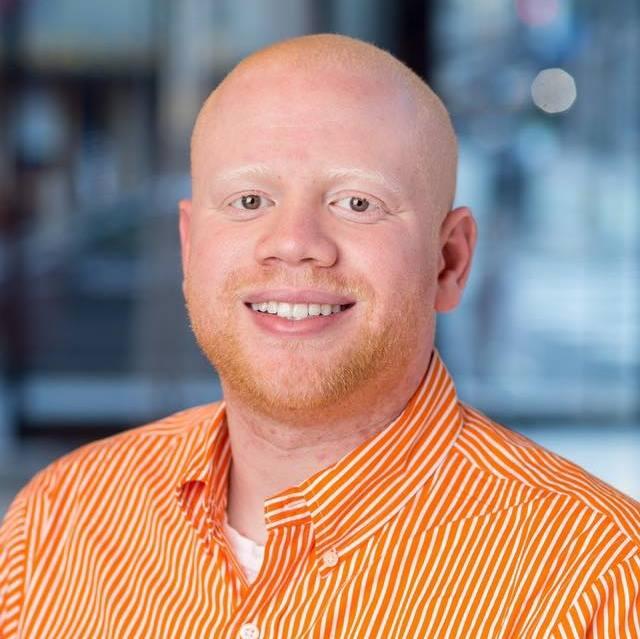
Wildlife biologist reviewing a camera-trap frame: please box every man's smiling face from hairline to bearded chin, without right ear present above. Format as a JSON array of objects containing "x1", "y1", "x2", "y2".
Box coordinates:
[{"x1": 181, "y1": 63, "x2": 438, "y2": 419}]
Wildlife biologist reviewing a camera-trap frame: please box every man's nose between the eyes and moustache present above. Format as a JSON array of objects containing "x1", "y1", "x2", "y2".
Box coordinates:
[{"x1": 256, "y1": 197, "x2": 338, "y2": 267}]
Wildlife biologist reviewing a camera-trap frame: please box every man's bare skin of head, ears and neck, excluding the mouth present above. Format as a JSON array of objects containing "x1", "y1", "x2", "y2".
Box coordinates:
[{"x1": 180, "y1": 34, "x2": 477, "y2": 543}]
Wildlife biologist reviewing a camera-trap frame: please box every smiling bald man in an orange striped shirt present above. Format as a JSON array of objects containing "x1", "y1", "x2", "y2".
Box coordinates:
[{"x1": 0, "y1": 35, "x2": 640, "y2": 639}]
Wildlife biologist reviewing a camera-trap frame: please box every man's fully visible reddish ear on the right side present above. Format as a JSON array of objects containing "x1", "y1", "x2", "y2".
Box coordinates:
[{"x1": 435, "y1": 206, "x2": 478, "y2": 313}]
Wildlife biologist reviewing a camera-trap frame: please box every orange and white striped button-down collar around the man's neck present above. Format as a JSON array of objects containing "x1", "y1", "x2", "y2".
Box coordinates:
[{"x1": 177, "y1": 348, "x2": 462, "y2": 576}]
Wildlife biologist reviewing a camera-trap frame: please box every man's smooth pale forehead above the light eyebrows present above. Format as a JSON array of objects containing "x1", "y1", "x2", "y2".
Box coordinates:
[{"x1": 198, "y1": 68, "x2": 415, "y2": 153}]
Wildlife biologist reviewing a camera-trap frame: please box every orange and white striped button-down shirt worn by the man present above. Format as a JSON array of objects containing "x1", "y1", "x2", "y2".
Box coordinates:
[{"x1": 0, "y1": 350, "x2": 640, "y2": 639}]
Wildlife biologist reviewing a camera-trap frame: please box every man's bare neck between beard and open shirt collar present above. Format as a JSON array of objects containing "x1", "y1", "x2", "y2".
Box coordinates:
[{"x1": 223, "y1": 356, "x2": 425, "y2": 544}]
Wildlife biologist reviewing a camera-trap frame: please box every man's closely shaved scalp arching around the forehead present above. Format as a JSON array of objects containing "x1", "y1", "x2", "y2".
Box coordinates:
[{"x1": 191, "y1": 34, "x2": 457, "y2": 221}]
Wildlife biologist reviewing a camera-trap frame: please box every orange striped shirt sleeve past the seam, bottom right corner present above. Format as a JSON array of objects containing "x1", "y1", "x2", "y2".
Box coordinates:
[{"x1": 553, "y1": 554, "x2": 640, "y2": 639}]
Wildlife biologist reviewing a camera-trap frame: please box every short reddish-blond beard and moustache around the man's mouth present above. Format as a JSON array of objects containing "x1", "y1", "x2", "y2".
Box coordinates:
[{"x1": 184, "y1": 268, "x2": 432, "y2": 425}]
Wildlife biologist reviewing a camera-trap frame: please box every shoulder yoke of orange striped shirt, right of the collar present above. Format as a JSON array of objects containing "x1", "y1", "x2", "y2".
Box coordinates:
[{"x1": 456, "y1": 404, "x2": 640, "y2": 548}]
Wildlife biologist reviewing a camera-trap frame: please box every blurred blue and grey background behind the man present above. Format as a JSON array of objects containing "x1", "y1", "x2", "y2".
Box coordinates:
[{"x1": 0, "y1": 0, "x2": 640, "y2": 515}]
